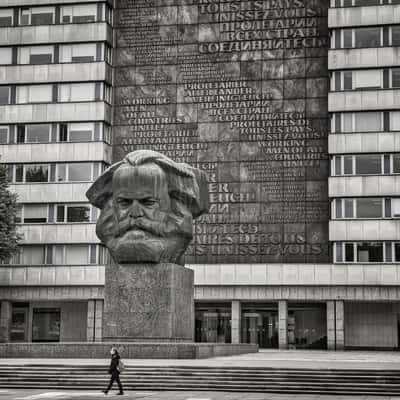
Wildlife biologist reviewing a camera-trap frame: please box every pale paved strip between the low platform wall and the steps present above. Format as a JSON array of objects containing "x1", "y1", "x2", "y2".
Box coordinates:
[{"x1": 0, "y1": 350, "x2": 400, "y2": 370}]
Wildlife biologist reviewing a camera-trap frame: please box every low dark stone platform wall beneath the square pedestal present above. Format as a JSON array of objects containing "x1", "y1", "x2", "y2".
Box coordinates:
[{"x1": 0, "y1": 342, "x2": 258, "y2": 359}]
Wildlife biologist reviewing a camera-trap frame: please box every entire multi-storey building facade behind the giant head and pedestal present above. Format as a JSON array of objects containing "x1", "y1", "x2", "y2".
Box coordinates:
[{"x1": 0, "y1": 0, "x2": 400, "y2": 349}]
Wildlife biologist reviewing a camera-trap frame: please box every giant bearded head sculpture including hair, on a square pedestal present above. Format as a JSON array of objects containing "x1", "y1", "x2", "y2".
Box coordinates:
[{"x1": 86, "y1": 150, "x2": 208, "y2": 264}]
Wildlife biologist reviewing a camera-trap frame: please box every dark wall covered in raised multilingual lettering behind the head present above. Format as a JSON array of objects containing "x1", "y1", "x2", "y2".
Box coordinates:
[{"x1": 114, "y1": 0, "x2": 329, "y2": 263}]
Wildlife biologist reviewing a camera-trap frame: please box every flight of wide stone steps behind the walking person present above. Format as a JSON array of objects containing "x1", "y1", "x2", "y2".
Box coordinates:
[{"x1": 0, "y1": 364, "x2": 400, "y2": 396}]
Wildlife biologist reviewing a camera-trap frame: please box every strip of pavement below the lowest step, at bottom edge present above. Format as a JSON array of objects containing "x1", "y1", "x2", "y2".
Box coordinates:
[{"x1": 0, "y1": 389, "x2": 400, "y2": 400}]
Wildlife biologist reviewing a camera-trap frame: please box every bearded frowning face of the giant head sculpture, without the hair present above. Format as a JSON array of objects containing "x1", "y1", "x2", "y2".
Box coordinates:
[{"x1": 97, "y1": 163, "x2": 192, "y2": 263}]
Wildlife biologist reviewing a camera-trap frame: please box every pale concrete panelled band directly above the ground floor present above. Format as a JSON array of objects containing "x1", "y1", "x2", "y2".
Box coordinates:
[{"x1": 0, "y1": 264, "x2": 400, "y2": 290}]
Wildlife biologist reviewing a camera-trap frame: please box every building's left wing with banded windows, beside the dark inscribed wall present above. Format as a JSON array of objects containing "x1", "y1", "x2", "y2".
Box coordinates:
[{"x1": 0, "y1": 0, "x2": 112, "y2": 341}]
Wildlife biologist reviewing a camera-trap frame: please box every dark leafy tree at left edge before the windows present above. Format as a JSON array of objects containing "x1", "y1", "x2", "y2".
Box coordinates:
[{"x1": 0, "y1": 165, "x2": 21, "y2": 262}]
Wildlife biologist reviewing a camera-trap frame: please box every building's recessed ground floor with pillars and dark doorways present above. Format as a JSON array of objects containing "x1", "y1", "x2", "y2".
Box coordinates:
[{"x1": 0, "y1": 299, "x2": 400, "y2": 350}]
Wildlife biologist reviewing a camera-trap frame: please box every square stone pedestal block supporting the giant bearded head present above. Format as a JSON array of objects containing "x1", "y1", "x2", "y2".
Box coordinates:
[{"x1": 103, "y1": 263, "x2": 194, "y2": 342}]
